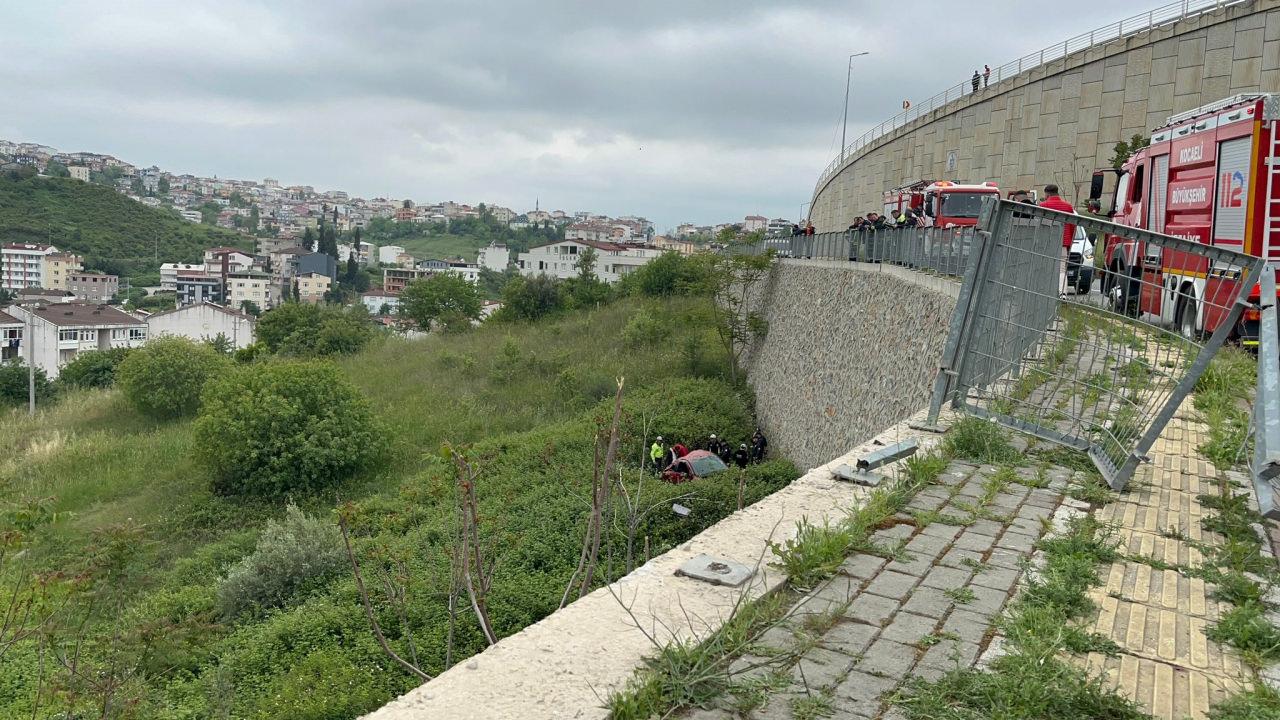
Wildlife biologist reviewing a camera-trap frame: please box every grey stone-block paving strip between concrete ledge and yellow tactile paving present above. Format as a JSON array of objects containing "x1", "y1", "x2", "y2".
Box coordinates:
[{"x1": 684, "y1": 462, "x2": 1075, "y2": 720}]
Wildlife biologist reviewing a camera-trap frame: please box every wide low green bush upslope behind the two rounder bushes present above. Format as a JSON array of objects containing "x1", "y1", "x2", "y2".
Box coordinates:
[{"x1": 256, "y1": 302, "x2": 374, "y2": 357}]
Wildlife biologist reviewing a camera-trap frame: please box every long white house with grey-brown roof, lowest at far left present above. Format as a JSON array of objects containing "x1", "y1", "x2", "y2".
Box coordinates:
[{"x1": 6, "y1": 302, "x2": 147, "y2": 378}]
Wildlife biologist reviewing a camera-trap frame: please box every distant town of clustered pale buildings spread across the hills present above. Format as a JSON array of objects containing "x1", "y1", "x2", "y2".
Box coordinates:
[{"x1": 0, "y1": 140, "x2": 790, "y2": 378}]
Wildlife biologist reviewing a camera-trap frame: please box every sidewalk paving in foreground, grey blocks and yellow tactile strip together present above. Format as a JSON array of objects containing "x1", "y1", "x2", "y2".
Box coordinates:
[{"x1": 684, "y1": 407, "x2": 1269, "y2": 720}]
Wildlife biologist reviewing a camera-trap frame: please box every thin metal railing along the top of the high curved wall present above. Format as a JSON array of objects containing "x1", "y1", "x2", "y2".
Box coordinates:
[{"x1": 814, "y1": 0, "x2": 1252, "y2": 195}]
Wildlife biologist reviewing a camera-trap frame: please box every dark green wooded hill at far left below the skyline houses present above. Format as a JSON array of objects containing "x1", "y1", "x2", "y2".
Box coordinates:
[{"x1": 0, "y1": 176, "x2": 252, "y2": 277}]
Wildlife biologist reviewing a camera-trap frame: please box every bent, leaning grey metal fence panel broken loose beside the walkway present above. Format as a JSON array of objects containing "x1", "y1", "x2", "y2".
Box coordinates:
[{"x1": 931, "y1": 200, "x2": 1264, "y2": 489}]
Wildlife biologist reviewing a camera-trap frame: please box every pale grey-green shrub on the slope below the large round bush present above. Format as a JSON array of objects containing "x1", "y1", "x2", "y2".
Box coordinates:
[{"x1": 218, "y1": 503, "x2": 346, "y2": 618}]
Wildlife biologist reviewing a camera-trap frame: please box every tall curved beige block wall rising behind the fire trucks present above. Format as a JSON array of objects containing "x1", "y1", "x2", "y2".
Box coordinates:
[{"x1": 810, "y1": 0, "x2": 1280, "y2": 232}]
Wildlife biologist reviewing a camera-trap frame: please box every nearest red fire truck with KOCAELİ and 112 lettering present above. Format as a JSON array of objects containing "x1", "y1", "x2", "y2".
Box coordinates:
[{"x1": 1094, "y1": 94, "x2": 1280, "y2": 345}]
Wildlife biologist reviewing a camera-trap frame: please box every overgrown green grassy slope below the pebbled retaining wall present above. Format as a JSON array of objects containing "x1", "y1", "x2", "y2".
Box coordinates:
[{"x1": 0, "y1": 299, "x2": 796, "y2": 720}]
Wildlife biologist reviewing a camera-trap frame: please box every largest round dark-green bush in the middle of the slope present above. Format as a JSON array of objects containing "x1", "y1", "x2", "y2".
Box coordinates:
[{"x1": 195, "y1": 361, "x2": 387, "y2": 495}]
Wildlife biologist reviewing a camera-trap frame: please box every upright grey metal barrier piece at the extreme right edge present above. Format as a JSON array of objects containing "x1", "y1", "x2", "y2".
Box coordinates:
[{"x1": 1251, "y1": 265, "x2": 1280, "y2": 520}]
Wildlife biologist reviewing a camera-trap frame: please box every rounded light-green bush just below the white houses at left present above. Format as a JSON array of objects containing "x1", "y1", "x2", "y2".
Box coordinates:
[{"x1": 115, "y1": 337, "x2": 230, "y2": 418}]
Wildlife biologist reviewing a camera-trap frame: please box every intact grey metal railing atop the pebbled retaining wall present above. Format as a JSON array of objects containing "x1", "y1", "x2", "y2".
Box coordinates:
[{"x1": 740, "y1": 228, "x2": 977, "y2": 277}]
